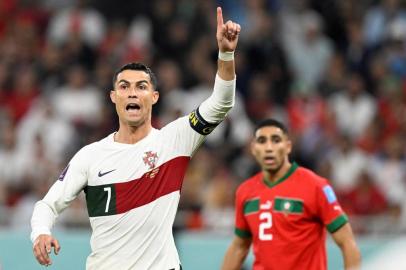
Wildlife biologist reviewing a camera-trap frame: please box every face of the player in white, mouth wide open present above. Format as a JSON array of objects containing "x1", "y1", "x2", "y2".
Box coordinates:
[{"x1": 110, "y1": 70, "x2": 159, "y2": 127}]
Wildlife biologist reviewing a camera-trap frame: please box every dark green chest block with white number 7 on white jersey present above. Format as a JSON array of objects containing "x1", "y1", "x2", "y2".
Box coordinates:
[{"x1": 85, "y1": 184, "x2": 117, "y2": 217}]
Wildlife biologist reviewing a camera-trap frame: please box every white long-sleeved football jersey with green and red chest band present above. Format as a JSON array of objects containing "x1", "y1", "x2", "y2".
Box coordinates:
[{"x1": 31, "y1": 74, "x2": 235, "y2": 270}]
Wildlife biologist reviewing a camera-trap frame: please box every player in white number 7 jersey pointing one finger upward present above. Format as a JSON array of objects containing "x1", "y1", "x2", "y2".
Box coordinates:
[{"x1": 31, "y1": 8, "x2": 241, "y2": 270}]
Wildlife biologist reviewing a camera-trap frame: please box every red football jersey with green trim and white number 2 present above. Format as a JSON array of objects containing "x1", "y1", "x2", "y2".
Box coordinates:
[{"x1": 235, "y1": 163, "x2": 348, "y2": 270}]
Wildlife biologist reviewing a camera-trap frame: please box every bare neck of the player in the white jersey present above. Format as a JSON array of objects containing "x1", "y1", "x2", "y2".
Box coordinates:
[{"x1": 114, "y1": 123, "x2": 152, "y2": 144}]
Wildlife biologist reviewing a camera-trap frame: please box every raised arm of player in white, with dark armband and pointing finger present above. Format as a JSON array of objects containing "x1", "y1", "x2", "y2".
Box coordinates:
[{"x1": 165, "y1": 7, "x2": 241, "y2": 155}]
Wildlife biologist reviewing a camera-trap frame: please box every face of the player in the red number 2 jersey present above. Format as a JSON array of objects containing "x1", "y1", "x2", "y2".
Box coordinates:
[{"x1": 251, "y1": 126, "x2": 292, "y2": 173}]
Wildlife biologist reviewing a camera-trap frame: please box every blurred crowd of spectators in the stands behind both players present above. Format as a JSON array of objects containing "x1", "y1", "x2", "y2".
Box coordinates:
[{"x1": 0, "y1": 0, "x2": 406, "y2": 234}]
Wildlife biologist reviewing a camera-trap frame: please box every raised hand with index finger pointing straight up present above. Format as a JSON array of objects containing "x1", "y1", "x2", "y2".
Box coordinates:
[{"x1": 216, "y1": 7, "x2": 241, "y2": 52}]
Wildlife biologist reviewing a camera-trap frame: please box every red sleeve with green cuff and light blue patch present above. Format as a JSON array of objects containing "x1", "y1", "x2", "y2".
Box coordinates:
[{"x1": 316, "y1": 180, "x2": 348, "y2": 233}]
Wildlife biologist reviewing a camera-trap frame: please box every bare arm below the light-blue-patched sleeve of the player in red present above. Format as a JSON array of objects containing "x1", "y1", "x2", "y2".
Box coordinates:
[{"x1": 332, "y1": 223, "x2": 361, "y2": 270}]
